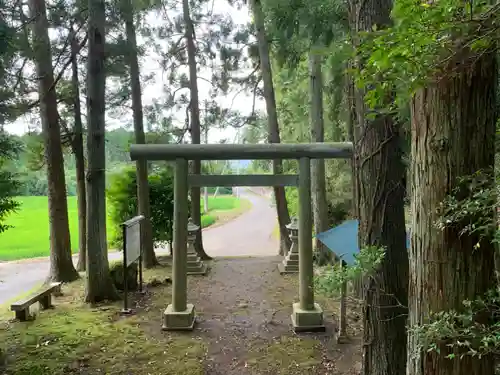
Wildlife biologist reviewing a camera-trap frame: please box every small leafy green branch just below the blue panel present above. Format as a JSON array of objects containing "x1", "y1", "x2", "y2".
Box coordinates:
[{"x1": 314, "y1": 246, "x2": 385, "y2": 296}]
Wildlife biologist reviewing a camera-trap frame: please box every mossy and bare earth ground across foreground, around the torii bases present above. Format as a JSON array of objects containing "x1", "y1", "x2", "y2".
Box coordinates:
[{"x1": 0, "y1": 257, "x2": 358, "y2": 375}]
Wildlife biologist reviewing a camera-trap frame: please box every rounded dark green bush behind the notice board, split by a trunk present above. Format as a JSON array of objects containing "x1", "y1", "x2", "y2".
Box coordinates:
[{"x1": 107, "y1": 167, "x2": 179, "y2": 248}]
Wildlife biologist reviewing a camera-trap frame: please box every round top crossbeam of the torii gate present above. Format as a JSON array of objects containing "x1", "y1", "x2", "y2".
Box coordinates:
[{"x1": 130, "y1": 142, "x2": 353, "y2": 160}]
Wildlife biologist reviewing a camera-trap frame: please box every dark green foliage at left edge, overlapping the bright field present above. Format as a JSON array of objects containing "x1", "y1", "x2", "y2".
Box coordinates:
[{"x1": 0, "y1": 130, "x2": 21, "y2": 233}]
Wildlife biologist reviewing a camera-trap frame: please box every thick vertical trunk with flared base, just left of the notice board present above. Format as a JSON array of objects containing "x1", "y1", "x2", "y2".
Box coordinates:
[{"x1": 85, "y1": 0, "x2": 119, "y2": 303}]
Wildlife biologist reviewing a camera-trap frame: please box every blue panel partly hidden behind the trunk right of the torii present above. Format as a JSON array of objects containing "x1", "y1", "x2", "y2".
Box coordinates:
[{"x1": 316, "y1": 220, "x2": 410, "y2": 265}]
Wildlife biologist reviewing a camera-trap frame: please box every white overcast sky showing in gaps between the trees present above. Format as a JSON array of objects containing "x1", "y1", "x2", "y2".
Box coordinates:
[{"x1": 5, "y1": 0, "x2": 265, "y2": 143}]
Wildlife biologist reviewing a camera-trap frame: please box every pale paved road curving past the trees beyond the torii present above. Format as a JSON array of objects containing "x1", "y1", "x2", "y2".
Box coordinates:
[{"x1": 0, "y1": 191, "x2": 278, "y2": 304}]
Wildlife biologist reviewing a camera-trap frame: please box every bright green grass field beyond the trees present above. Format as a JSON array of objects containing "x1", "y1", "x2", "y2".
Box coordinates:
[{"x1": 0, "y1": 195, "x2": 241, "y2": 261}]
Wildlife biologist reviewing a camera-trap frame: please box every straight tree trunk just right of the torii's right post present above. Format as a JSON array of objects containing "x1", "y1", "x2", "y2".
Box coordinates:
[{"x1": 309, "y1": 51, "x2": 332, "y2": 265}]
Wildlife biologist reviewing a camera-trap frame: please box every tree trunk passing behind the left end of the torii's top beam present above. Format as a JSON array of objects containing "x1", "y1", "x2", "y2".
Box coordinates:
[{"x1": 123, "y1": 0, "x2": 158, "y2": 268}]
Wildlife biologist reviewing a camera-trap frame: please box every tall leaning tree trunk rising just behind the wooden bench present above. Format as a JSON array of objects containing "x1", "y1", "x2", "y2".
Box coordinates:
[{"x1": 29, "y1": 0, "x2": 79, "y2": 282}]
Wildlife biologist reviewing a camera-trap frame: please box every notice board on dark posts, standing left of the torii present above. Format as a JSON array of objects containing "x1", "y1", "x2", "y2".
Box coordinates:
[{"x1": 121, "y1": 215, "x2": 144, "y2": 315}]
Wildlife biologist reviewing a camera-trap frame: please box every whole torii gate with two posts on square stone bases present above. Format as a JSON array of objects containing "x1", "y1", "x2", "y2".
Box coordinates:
[{"x1": 130, "y1": 143, "x2": 352, "y2": 332}]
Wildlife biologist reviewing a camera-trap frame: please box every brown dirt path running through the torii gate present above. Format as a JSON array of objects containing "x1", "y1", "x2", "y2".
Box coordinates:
[{"x1": 189, "y1": 257, "x2": 359, "y2": 375}]
